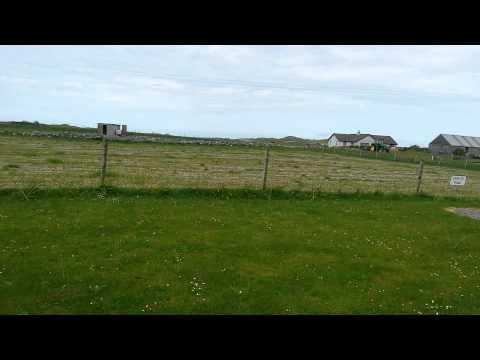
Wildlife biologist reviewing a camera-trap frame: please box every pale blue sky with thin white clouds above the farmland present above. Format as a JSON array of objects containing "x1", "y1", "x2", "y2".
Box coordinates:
[{"x1": 0, "y1": 45, "x2": 480, "y2": 146}]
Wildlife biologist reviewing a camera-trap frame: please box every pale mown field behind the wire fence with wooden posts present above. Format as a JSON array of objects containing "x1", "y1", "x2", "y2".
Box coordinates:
[{"x1": 0, "y1": 136, "x2": 480, "y2": 197}]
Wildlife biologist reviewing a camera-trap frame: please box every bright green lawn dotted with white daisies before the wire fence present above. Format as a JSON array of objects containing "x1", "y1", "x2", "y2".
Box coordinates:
[{"x1": 0, "y1": 190, "x2": 480, "y2": 314}]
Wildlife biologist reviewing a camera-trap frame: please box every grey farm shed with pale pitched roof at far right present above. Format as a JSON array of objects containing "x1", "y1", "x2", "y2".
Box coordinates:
[{"x1": 429, "y1": 134, "x2": 480, "y2": 156}]
